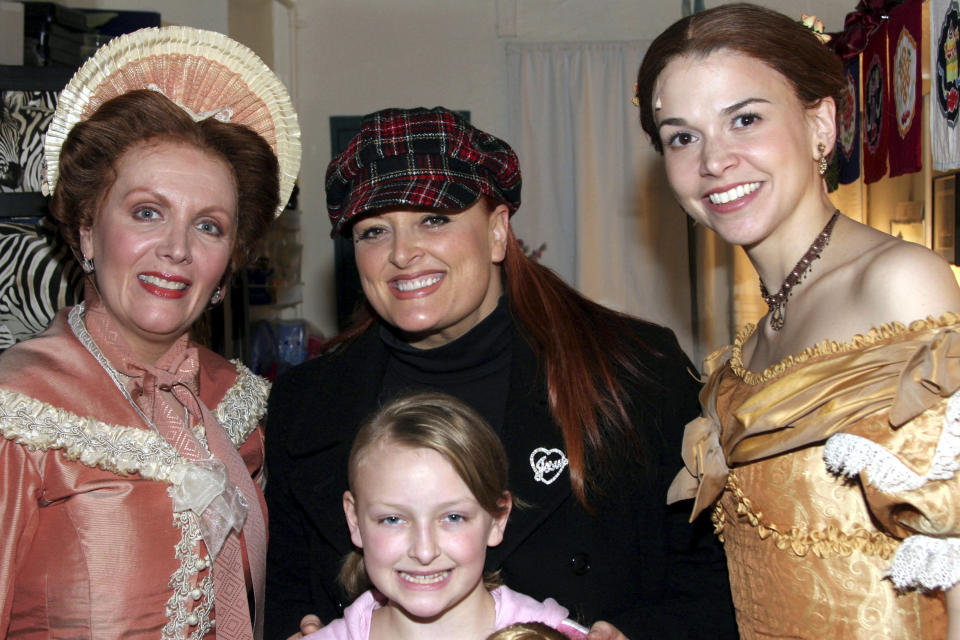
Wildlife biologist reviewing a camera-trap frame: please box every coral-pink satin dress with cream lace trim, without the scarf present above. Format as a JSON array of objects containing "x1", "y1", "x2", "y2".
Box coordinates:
[{"x1": 0, "y1": 296, "x2": 268, "y2": 639}]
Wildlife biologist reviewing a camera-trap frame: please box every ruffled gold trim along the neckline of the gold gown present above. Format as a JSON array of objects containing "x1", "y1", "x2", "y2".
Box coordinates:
[{"x1": 730, "y1": 312, "x2": 960, "y2": 385}]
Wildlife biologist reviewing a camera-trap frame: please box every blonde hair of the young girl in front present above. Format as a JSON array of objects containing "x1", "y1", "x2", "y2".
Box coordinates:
[{"x1": 338, "y1": 392, "x2": 510, "y2": 599}]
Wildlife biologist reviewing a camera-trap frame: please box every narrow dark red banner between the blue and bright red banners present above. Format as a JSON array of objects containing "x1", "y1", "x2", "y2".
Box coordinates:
[{"x1": 863, "y1": 23, "x2": 889, "y2": 184}]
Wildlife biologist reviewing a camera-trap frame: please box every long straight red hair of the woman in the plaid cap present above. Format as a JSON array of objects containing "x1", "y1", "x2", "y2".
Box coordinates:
[{"x1": 324, "y1": 212, "x2": 659, "y2": 508}]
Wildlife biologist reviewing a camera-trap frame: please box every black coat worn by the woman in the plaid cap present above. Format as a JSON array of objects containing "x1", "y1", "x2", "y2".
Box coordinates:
[{"x1": 265, "y1": 322, "x2": 737, "y2": 640}]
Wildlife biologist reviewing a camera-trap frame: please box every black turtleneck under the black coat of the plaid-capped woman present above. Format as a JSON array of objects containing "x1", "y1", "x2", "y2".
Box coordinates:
[{"x1": 379, "y1": 296, "x2": 513, "y2": 434}]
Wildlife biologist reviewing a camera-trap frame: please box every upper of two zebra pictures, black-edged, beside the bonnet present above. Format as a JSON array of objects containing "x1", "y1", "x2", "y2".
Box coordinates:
[{"x1": 0, "y1": 66, "x2": 74, "y2": 218}]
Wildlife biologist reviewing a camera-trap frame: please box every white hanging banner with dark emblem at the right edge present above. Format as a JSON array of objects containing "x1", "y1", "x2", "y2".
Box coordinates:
[{"x1": 930, "y1": 0, "x2": 960, "y2": 171}]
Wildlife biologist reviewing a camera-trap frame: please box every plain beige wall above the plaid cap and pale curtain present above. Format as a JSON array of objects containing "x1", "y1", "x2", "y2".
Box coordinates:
[{"x1": 274, "y1": 0, "x2": 856, "y2": 332}]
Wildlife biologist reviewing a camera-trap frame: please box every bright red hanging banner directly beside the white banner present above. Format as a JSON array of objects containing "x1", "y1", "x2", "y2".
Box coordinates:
[{"x1": 887, "y1": 0, "x2": 923, "y2": 178}]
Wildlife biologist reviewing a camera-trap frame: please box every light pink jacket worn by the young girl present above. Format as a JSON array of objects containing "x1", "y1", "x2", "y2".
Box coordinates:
[{"x1": 306, "y1": 587, "x2": 587, "y2": 640}]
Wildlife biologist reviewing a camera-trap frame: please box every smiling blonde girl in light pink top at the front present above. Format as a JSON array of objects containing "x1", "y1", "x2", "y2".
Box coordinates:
[{"x1": 308, "y1": 393, "x2": 586, "y2": 640}]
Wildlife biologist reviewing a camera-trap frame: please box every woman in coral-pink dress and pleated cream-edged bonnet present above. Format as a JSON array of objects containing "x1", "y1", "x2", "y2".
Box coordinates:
[{"x1": 0, "y1": 28, "x2": 299, "y2": 639}]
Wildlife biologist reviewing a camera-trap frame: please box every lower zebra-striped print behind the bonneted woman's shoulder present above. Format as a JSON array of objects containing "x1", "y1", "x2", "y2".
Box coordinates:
[{"x1": 0, "y1": 222, "x2": 83, "y2": 349}]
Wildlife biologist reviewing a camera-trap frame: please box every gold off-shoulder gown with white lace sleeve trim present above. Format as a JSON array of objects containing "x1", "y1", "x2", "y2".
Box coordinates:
[{"x1": 671, "y1": 314, "x2": 960, "y2": 640}]
